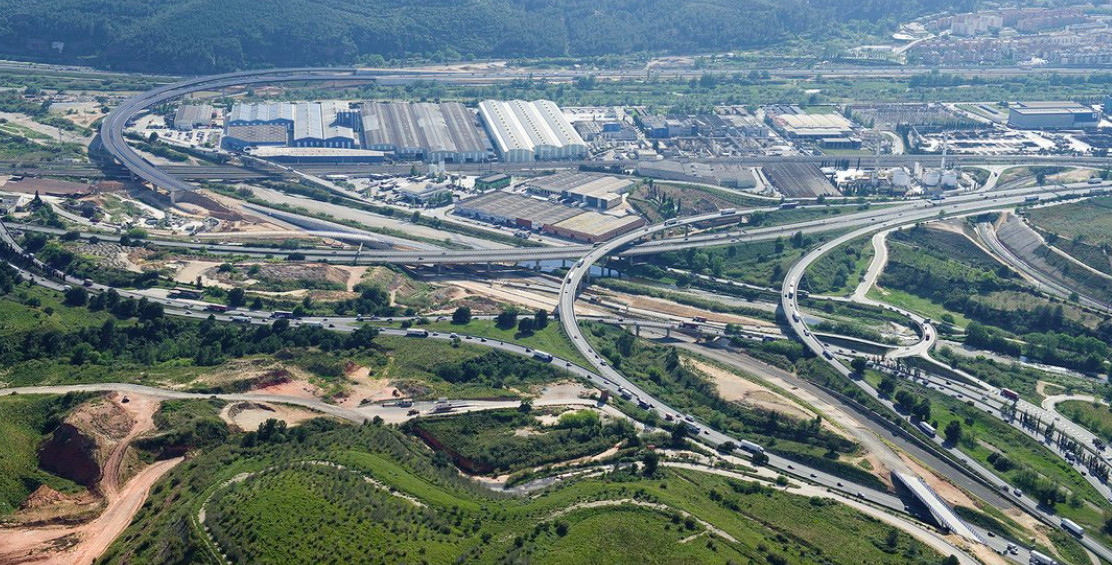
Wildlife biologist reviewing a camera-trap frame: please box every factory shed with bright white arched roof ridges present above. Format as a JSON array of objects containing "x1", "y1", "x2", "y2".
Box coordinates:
[{"x1": 479, "y1": 100, "x2": 587, "y2": 162}]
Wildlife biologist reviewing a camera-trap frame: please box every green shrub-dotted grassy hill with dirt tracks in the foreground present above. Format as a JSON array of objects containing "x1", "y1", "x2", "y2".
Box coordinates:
[{"x1": 101, "y1": 418, "x2": 942, "y2": 565}]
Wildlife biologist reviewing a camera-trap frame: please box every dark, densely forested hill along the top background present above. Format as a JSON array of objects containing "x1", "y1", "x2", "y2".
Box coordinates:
[{"x1": 0, "y1": 0, "x2": 974, "y2": 73}]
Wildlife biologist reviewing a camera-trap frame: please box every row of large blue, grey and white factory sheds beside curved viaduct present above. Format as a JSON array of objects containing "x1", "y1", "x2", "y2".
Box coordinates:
[{"x1": 223, "y1": 100, "x2": 587, "y2": 162}]
